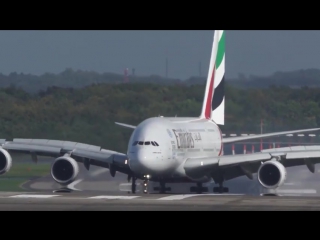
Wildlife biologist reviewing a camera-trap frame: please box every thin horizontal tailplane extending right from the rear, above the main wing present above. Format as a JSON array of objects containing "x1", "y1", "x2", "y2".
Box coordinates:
[{"x1": 222, "y1": 128, "x2": 320, "y2": 143}]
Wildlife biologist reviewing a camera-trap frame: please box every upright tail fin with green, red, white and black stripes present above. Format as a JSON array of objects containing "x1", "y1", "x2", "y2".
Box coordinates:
[{"x1": 200, "y1": 30, "x2": 225, "y2": 125}]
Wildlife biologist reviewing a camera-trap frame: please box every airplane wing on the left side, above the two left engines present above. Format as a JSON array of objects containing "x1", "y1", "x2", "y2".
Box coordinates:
[{"x1": 0, "y1": 138, "x2": 130, "y2": 174}]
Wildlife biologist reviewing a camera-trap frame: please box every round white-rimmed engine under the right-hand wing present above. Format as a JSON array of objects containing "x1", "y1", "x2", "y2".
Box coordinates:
[{"x1": 258, "y1": 161, "x2": 287, "y2": 189}]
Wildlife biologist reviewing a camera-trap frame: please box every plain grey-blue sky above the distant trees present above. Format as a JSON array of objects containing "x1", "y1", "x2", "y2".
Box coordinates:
[{"x1": 0, "y1": 30, "x2": 320, "y2": 80}]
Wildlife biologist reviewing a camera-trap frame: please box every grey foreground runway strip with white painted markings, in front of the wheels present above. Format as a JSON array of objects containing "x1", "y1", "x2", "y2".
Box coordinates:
[{"x1": 0, "y1": 193, "x2": 320, "y2": 211}]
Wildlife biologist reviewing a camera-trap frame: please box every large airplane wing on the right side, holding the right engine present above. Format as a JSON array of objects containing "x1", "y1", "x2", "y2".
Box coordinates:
[{"x1": 184, "y1": 146, "x2": 320, "y2": 180}]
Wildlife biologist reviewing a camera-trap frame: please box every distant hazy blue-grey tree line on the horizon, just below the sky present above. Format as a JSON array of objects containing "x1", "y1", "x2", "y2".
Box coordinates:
[{"x1": 0, "y1": 68, "x2": 320, "y2": 93}]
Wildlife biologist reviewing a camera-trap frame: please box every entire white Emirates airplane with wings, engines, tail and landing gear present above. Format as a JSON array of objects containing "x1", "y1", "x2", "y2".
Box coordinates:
[{"x1": 0, "y1": 30, "x2": 320, "y2": 193}]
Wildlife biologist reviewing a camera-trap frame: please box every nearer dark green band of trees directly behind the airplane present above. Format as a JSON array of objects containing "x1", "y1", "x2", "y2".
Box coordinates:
[{"x1": 0, "y1": 82, "x2": 320, "y2": 152}]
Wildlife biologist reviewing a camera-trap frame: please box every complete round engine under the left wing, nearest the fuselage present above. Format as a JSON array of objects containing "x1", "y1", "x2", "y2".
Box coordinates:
[{"x1": 51, "y1": 156, "x2": 79, "y2": 186}]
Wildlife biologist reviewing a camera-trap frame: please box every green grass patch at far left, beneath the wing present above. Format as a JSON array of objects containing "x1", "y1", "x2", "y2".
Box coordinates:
[{"x1": 0, "y1": 161, "x2": 51, "y2": 191}]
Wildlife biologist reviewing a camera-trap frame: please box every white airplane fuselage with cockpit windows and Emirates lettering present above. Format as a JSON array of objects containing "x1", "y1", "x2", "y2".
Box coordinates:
[{"x1": 127, "y1": 117, "x2": 222, "y2": 182}]
